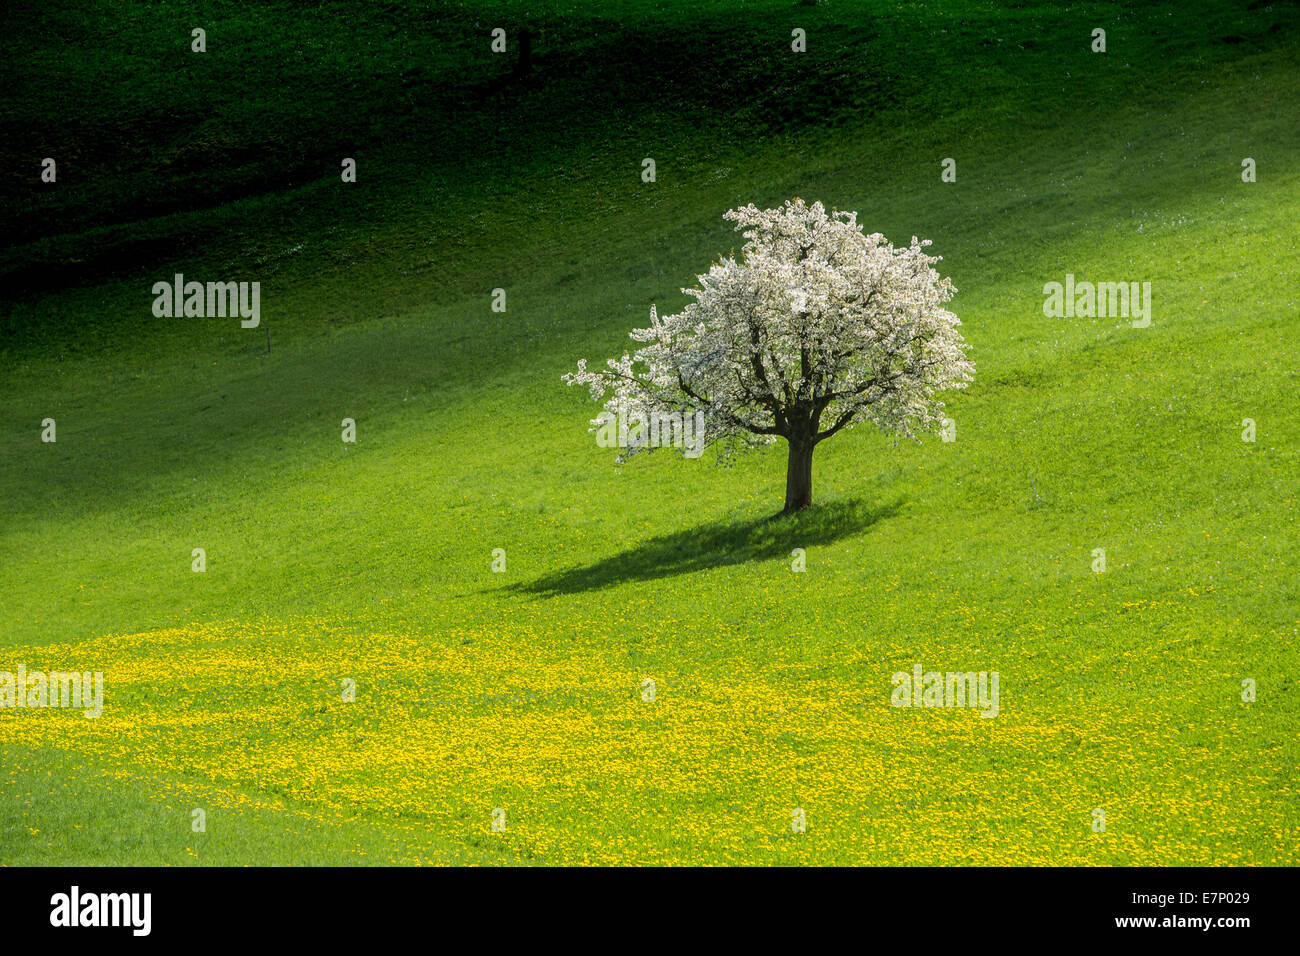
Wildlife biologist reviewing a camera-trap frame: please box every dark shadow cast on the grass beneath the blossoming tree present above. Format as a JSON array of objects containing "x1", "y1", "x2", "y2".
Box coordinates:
[{"x1": 511, "y1": 498, "x2": 904, "y2": 597}]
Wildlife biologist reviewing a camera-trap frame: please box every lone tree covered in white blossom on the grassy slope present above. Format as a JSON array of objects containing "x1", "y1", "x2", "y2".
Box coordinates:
[{"x1": 564, "y1": 199, "x2": 975, "y2": 514}]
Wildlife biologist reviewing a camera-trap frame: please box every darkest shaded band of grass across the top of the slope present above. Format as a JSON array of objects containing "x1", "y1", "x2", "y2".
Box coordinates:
[{"x1": 0, "y1": 0, "x2": 1296, "y2": 310}]
